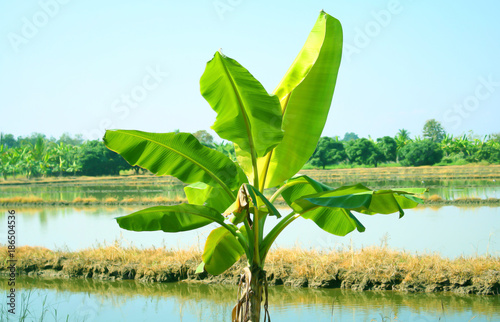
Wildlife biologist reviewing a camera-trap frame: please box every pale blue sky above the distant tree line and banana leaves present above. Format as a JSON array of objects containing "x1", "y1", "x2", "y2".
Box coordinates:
[{"x1": 0, "y1": 0, "x2": 500, "y2": 138}]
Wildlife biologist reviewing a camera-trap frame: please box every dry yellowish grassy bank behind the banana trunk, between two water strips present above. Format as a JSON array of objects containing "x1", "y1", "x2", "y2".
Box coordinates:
[{"x1": 0, "y1": 245, "x2": 500, "y2": 295}]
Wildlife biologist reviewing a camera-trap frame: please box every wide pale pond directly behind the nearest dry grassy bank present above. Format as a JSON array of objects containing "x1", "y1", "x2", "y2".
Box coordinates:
[{"x1": 0, "y1": 206, "x2": 500, "y2": 258}]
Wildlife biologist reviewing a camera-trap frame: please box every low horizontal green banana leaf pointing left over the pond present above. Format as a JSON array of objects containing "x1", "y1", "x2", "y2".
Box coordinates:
[{"x1": 116, "y1": 204, "x2": 224, "y2": 233}]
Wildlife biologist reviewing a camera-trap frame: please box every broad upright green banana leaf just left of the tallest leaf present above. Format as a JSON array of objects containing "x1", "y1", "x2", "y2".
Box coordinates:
[{"x1": 200, "y1": 52, "x2": 283, "y2": 180}]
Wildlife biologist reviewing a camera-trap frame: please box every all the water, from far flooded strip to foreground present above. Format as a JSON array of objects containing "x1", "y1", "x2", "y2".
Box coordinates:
[{"x1": 0, "y1": 182, "x2": 500, "y2": 321}]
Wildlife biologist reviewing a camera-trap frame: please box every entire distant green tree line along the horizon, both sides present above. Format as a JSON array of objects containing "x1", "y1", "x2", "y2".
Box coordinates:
[{"x1": 0, "y1": 120, "x2": 500, "y2": 179}]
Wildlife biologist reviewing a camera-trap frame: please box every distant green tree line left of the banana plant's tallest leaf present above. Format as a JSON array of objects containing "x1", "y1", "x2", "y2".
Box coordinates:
[{"x1": 0, "y1": 131, "x2": 236, "y2": 179}]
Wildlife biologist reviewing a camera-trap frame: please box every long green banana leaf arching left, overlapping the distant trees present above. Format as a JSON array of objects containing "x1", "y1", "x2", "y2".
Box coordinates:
[{"x1": 104, "y1": 130, "x2": 248, "y2": 197}]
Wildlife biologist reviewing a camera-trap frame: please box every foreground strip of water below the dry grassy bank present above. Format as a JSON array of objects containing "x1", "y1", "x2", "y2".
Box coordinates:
[{"x1": 0, "y1": 277, "x2": 500, "y2": 322}]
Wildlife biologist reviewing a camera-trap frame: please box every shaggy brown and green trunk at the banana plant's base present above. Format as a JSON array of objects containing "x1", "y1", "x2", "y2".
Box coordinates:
[{"x1": 233, "y1": 265, "x2": 269, "y2": 322}]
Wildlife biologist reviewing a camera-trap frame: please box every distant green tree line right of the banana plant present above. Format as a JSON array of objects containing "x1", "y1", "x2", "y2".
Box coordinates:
[{"x1": 309, "y1": 119, "x2": 500, "y2": 169}]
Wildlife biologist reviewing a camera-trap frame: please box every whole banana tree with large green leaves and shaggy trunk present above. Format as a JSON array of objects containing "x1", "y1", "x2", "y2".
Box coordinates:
[{"x1": 104, "y1": 11, "x2": 421, "y2": 321}]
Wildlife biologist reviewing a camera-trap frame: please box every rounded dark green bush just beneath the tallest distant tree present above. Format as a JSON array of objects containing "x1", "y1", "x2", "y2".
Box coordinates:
[{"x1": 398, "y1": 139, "x2": 443, "y2": 166}]
